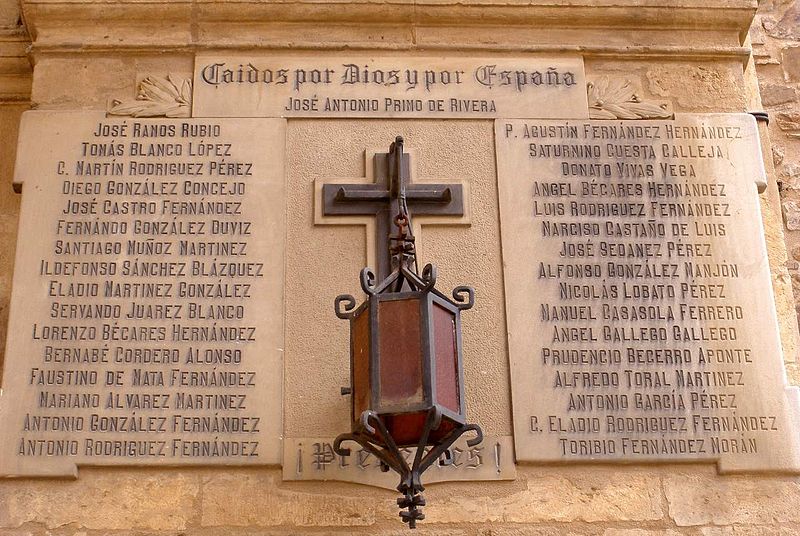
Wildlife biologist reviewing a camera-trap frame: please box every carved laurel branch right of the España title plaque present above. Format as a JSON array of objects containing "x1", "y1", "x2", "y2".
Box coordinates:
[{"x1": 586, "y1": 76, "x2": 673, "y2": 119}]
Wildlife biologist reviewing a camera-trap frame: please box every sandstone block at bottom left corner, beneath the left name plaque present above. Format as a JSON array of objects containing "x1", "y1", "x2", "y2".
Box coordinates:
[{"x1": 0, "y1": 469, "x2": 199, "y2": 530}]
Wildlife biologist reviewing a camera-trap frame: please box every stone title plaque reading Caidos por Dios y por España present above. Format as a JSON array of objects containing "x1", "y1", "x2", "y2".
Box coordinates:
[{"x1": 192, "y1": 54, "x2": 588, "y2": 119}]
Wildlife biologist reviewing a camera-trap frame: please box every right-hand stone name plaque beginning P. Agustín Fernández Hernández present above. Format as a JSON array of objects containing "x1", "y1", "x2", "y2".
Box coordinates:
[{"x1": 496, "y1": 114, "x2": 800, "y2": 471}]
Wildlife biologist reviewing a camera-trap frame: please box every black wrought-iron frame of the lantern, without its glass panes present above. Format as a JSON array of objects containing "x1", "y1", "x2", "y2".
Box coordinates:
[{"x1": 333, "y1": 137, "x2": 483, "y2": 528}]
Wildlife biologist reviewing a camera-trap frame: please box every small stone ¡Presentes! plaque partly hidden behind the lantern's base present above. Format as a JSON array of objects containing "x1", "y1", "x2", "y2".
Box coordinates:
[{"x1": 283, "y1": 436, "x2": 517, "y2": 490}]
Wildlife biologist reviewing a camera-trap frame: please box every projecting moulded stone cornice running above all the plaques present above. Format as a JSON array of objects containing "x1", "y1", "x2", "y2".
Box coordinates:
[{"x1": 17, "y1": 0, "x2": 754, "y2": 54}]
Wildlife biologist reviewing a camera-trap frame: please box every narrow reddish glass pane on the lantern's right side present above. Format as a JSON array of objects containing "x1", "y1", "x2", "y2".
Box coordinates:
[{"x1": 432, "y1": 303, "x2": 461, "y2": 414}]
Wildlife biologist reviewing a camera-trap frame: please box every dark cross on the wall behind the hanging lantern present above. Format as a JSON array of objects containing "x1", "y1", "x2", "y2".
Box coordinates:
[{"x1": 322, "y1": 136, "x2": 464, "y2": 281}]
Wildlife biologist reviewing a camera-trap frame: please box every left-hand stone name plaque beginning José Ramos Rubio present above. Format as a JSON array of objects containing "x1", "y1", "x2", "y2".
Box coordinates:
[{"x1": 0, "y1": 112, "x2": 285, "y2": 475}]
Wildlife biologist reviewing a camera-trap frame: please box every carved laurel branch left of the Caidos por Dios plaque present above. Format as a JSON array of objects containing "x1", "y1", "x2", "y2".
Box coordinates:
[{"x1": 108, "y1": 74, "x2": 192, "y2": 117}]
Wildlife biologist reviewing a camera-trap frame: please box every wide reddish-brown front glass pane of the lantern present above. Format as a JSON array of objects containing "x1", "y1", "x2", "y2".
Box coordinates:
[{"x1": 378, "y1": 298, "x2": 425, "y2": 407}]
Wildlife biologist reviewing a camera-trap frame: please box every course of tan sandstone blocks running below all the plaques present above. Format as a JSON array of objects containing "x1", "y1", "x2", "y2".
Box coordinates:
[{"x1": 0, "y1": 466, "x2": 800, "y2": 536}]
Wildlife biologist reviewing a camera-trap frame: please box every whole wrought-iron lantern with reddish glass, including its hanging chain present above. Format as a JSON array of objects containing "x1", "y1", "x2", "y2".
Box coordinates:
[{"x1": 334, "y1": 137, "x2": 483, "y2": 528}]
